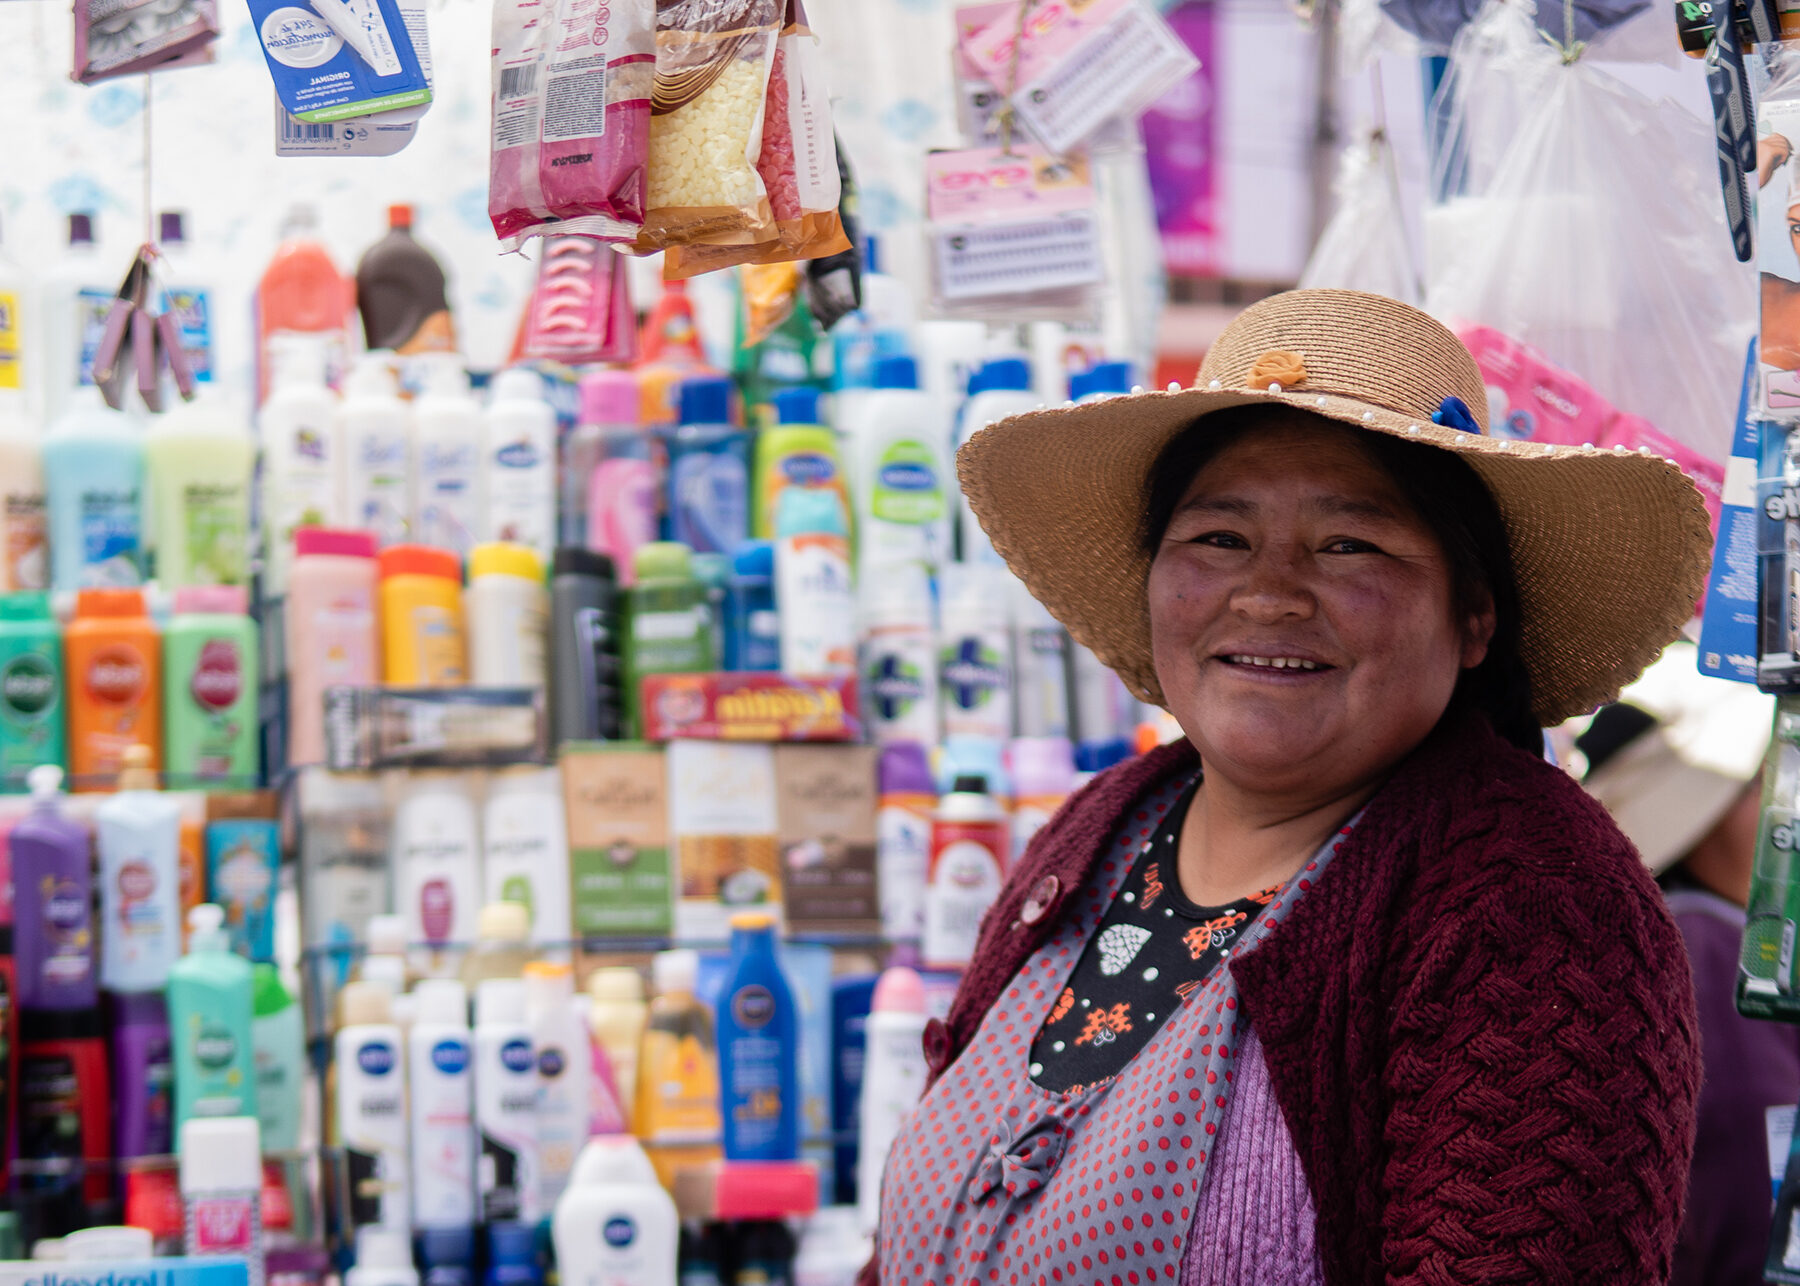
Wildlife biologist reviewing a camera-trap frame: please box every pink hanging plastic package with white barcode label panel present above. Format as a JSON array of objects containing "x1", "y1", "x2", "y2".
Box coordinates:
[{"x1": 488, "y1": 0, "x2": 657, "y2": 250}]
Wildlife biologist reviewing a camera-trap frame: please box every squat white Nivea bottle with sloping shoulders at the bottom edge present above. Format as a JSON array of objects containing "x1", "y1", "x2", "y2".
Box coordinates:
[{"x1": 551, "y1": 1135, "x2": 680, "y2": 1286}]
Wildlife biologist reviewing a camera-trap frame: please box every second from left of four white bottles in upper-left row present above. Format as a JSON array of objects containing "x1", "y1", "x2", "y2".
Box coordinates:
[{"x1": 338, "y1": 351, "x2": 414, "y2": 546}]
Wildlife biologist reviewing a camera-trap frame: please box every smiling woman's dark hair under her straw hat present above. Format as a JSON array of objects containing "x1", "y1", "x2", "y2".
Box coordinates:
[{"x1": 1139, "y1": 407, "x2": 1544, "y2": 755}]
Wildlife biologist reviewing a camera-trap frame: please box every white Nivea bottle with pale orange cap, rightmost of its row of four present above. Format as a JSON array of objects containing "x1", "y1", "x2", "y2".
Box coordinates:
[{"x1": 526, "y1": 960, "x2": 594, "y2": 1210}]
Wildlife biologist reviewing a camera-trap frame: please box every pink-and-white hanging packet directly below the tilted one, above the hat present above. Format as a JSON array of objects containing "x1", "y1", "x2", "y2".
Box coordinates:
[{"x1": 925, "y1": 144, "x2": 1105, "y2": 322}]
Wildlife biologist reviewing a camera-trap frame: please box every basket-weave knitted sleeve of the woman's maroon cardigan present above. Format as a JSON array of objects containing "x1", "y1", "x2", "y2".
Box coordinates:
[{"x1": 1382, "y1": 848, "x2": 1699, "y2": 1286}]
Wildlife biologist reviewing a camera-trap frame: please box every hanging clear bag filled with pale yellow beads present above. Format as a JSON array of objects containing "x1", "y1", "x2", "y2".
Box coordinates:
[{"x1": 637, "y1": 0, "x2": 783, "y2": 252}]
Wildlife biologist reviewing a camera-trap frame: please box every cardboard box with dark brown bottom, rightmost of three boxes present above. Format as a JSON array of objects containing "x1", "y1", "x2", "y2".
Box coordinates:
[{"x1": 776, "y1": 746, "x2": 882, "y2": 935}]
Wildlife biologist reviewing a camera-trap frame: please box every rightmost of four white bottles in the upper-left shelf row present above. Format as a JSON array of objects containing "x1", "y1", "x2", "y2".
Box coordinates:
[{"x1": 481, "y1": 369, "x2": 556, "y2": 562}]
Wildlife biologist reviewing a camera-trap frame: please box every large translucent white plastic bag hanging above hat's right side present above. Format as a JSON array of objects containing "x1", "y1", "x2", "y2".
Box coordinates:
[{"x1": 1426, "y1": 5, "x2": 1755, "y2": 461}]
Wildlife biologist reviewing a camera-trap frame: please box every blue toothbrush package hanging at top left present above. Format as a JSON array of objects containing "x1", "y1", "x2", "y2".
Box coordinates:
[{"x1": 248, "y1": 0, "x2": 432, "y2": 124}]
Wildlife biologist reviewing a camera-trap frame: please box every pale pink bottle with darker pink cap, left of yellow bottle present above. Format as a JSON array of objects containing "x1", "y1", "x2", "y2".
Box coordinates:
[{"x1": 286, "y1": 528, "x2": 380, "y2": 765}]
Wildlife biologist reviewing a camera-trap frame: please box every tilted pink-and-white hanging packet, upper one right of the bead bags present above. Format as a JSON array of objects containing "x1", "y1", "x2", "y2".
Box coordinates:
[{"x1": 961, "y1": 0, "x2": 1201, "y2": 151}]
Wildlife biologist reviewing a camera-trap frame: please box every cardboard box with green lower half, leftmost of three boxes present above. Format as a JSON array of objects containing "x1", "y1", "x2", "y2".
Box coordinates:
[{"x1": 562, "y1": 742, "x2": 675, "y2": 938}]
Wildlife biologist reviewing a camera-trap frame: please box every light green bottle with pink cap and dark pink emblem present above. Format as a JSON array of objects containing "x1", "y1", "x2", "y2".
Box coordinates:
[{"x1": 162, "y1": 585, "x2": 261, "y2": 791}]
